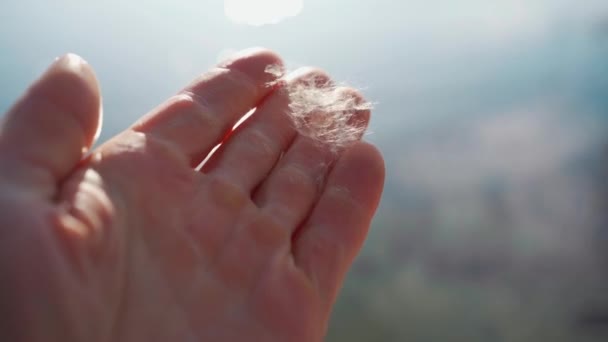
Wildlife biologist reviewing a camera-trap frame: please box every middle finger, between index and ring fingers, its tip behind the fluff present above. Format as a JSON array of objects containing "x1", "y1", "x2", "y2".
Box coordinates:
[{"x1": 202, "y1": 68, "x2": 329, "y2": 192}]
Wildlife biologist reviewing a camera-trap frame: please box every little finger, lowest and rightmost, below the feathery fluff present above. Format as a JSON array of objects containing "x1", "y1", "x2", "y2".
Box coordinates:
[{"x1": 293, "y1": 142, "x2": 384, "y2": 305}]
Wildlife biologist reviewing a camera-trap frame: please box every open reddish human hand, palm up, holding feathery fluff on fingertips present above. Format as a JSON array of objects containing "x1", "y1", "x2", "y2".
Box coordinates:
[{"x1": 0, "y1": 49, "x2": 384, "y2": 341}]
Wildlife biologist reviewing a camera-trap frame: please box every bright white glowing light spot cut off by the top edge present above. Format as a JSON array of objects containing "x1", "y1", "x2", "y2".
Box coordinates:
[{"x1": 224, "y1": 0, "x2": 304, "y2": 26}]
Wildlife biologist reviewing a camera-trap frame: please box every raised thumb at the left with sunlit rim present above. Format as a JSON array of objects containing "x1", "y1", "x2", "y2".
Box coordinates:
[{"x1": 0, "y1": 54, "x2": 101, "y2": 192}]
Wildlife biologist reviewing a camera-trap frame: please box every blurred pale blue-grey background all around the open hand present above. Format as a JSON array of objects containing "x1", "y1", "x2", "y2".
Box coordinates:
[{"x1": 0, "y1": 0, "x2": 608, "y2": 342}]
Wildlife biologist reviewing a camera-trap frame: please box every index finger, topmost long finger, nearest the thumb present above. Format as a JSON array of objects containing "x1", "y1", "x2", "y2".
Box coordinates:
[{"x1": 133, "y1": 49, "x2": 282, "y2": 166}]
